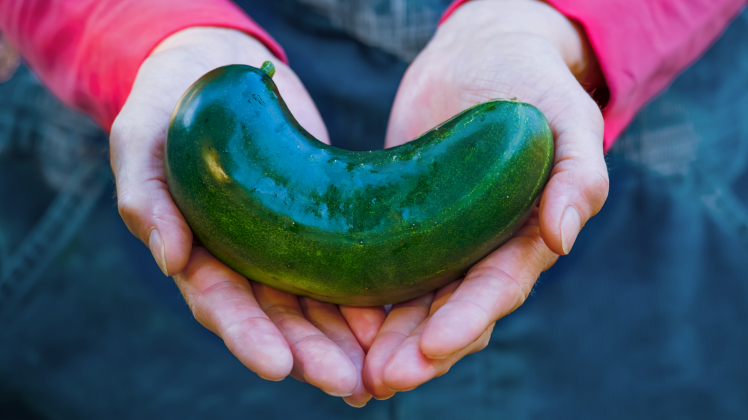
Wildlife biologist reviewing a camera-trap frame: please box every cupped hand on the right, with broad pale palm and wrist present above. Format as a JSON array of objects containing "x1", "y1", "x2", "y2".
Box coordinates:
[{"x1": 364, "y1": 0, "x2": 608, "y2": 398}]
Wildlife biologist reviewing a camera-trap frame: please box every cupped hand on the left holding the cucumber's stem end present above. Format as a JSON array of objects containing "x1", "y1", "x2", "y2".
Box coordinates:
[{"x1": 110, "y1": 28, "x2": 384, "y2": 406}]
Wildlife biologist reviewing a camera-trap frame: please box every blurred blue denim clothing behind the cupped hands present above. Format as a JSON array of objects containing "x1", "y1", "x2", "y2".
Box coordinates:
[{"x1": 0, "y1": 2, "x2": 748, "y2": 419}]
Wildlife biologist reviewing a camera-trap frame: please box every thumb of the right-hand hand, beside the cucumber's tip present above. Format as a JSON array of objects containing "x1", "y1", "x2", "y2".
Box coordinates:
[{"x1": 540, "y1": 94, "x2": 609, "y2": 255}]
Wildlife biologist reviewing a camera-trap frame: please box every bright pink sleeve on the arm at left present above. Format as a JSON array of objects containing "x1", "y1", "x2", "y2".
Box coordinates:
[{"x1": 0, "y1": 0, "x2": 286, "y2": 130}]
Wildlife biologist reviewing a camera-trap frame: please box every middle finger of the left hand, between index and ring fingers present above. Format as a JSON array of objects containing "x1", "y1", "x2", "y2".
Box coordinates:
[{"x1": 251, "y1": 282, "x2": 359, "y2": 397}]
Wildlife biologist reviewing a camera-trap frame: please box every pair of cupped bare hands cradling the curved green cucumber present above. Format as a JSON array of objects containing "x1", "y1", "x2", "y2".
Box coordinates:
[{"x1": 110, "y1": 0, "x2": 608, "y2": 406}]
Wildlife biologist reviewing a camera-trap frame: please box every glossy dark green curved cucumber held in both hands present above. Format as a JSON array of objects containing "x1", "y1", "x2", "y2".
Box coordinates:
[{"x1": 164, "y1": 65, "x2": 554, "y2": 306}]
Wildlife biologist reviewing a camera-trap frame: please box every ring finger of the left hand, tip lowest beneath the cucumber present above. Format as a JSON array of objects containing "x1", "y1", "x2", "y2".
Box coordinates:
[{"x1": 299, "y1": 297, "x2": 371, "y2": 407}]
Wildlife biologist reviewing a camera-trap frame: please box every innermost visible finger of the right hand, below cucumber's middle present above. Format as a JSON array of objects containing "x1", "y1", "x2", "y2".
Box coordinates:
[{"x1": 363, "y1": 293, "x2": 434, "y2": 400}]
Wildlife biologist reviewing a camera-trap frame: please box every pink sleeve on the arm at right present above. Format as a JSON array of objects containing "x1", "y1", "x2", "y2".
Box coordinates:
[{"x1": 442, "y1": 0, "x2": 745, "y2": 151}]
